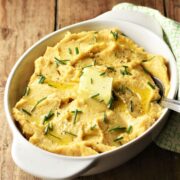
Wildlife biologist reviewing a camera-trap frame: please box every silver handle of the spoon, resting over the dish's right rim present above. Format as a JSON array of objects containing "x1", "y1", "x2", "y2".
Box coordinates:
[{"x1": 161, "y1": 98, "x2": 180, "y2": 113}]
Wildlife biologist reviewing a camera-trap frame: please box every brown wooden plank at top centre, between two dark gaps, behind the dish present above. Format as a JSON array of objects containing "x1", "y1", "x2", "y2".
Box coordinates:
[{"x1": 57, "y1": 0, "x2": 164, "y2": 28}]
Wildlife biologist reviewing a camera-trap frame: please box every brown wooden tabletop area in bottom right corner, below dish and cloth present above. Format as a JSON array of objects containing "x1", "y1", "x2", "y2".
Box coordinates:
[{"x1": 80, "y1": 143, "x2": 180, "y2": 180}]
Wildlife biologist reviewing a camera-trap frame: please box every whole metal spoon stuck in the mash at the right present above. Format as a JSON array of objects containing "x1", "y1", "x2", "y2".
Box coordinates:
[{"x1": 153, "y1": 77, "x2": 180, "y2": 113}]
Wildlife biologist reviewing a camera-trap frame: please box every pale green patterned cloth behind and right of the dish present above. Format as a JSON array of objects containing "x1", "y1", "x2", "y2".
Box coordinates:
[{"x1": 113, "y1": 3, "x2": 180, "y2": 153}]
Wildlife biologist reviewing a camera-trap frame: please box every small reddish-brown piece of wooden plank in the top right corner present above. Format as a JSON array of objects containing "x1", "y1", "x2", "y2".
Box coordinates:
[{"x1": 165, "y1": 0, "x2": 180, "y2": 22}]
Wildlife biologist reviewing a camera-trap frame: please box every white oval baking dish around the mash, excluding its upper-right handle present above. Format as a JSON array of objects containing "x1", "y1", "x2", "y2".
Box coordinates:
[{"x1": 4, "y1": 19, "x2": 178, "y2": 179}]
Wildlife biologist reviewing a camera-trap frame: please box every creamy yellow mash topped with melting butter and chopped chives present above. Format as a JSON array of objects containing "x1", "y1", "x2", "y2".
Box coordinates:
[{"x1": 13, "y1": 28, "x2": 169, "y2": 156}]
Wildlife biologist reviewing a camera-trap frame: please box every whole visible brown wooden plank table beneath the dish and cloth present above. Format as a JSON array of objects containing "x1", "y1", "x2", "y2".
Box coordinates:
[{"x1": 0, "y1": 0, "x2": 180, "y2": 180}]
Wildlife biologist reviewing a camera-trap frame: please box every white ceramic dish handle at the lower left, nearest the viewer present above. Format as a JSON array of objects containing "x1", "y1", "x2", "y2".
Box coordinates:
[{"x1": 11, "y1": 137, "x2": 95, "y2": 179}]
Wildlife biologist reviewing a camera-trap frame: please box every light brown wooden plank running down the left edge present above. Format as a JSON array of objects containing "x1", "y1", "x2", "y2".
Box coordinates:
[{"x1": 0, "y1": 0, "x2": 54, "y2": 180}]
